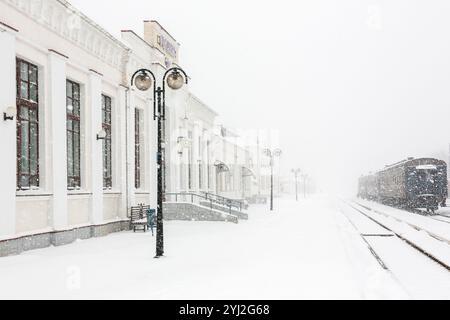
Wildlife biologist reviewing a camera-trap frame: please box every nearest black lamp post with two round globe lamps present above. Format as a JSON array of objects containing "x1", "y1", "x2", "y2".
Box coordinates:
[{"x1": 131, "y1": 68, "x2": 188, "y2": 258}]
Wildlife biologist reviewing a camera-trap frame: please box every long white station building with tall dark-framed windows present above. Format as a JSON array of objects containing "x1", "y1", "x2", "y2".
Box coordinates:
[{"x1": 0, "y1": 0, "x2": 257, "y2": 256}]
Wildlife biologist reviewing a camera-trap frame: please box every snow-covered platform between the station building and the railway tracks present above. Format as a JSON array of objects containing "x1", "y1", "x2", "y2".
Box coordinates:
[{"x1": 0, "y1": 197, "x2": 442, "y2": 300}]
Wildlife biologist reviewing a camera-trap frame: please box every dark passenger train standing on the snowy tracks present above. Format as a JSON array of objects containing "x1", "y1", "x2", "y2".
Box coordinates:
[{"x1": 358, "y1": 158, "x2": 448, "y2": 213}]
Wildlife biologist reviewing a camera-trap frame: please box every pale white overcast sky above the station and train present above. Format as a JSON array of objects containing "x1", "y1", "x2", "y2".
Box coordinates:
[{"x1": 71, "y1": 0, "x2": 450, "y2": 191}]
